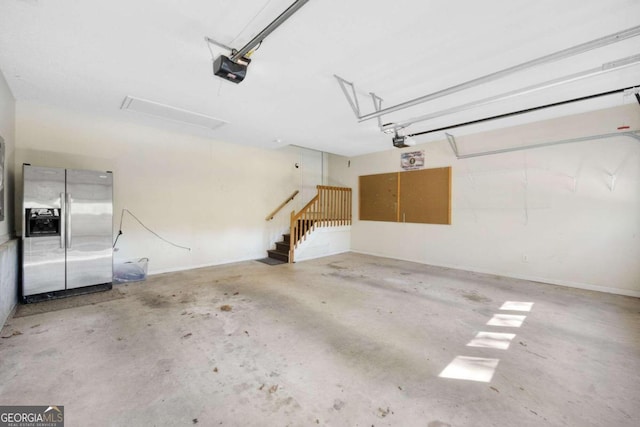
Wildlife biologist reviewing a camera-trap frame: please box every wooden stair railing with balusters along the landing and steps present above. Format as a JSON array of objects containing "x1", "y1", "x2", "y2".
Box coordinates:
[{"x1": 289, "y1": 185, "x2": 351, "y2": 263}]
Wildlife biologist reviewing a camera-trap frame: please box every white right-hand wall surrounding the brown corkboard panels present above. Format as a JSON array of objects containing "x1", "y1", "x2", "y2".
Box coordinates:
[{"x1": 329, "y1": 104, "x2": 640, "y2": 296}]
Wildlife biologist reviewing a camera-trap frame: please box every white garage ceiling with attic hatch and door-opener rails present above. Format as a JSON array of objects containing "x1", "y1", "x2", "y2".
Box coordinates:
[{"x1": 0, "y1": 0, "x2": 640, "y2": 156}]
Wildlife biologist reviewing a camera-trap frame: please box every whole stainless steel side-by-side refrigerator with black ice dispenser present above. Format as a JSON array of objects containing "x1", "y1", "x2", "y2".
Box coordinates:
[{"x1": 22, "y1": 164, "x2": 113, "y2": 302}]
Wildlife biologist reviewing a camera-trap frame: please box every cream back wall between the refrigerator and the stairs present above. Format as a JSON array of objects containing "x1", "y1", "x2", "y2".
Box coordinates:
[{"x1": 16, "y1": 101, "x2": 316, "y2": 274}]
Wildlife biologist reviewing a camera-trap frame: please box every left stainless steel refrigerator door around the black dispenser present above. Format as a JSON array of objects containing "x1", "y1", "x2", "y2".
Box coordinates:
[{"x1": 22, "y1": 165, "x2": 65, "y2": 296}]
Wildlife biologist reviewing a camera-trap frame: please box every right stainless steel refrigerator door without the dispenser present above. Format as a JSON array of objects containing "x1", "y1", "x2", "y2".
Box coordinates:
[{"x1": 65, "y1": 169, "x2": 113, "y2": 289}]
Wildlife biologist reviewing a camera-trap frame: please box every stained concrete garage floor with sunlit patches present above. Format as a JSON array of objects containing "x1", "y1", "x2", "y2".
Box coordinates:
[{"x1": 0, "y1": 254, "x2": 640, "y2": 427}]
